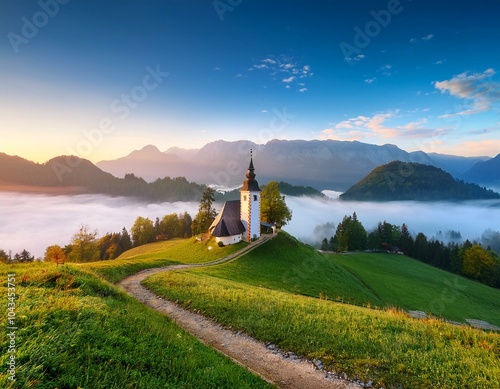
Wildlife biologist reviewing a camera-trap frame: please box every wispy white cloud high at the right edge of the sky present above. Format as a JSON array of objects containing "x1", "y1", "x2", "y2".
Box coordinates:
[{"x1": 434, "y1": 68, "x2": 500, "y2": 118}]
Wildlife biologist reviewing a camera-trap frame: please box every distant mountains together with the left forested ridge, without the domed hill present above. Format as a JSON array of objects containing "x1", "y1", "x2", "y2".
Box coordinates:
[{"x1": 0, "y1": 140, "x2": 500, "y2": 194}]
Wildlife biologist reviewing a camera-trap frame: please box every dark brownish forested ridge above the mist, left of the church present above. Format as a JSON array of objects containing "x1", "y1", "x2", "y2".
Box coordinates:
[{"x1": 0, "y1": 153, "x2": 204, "y2": 202}]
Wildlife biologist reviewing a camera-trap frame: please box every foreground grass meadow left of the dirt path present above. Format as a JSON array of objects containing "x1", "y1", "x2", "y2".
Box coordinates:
[{"x1": 0, "y1": 262, "x2": 270, "y2": 389}]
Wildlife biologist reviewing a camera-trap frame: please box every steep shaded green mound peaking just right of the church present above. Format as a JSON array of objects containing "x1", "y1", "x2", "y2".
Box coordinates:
[{"x1": 192, "y1": 233, "x2": 384, "y2": 306}]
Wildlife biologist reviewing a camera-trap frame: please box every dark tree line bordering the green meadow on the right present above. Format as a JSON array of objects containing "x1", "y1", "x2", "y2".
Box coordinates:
[{"x1": 321, "y1": 212, "x2": 500, "y2": 288}]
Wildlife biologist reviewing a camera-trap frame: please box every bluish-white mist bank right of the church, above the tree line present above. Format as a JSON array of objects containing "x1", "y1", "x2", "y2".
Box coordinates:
[{"x1": 285, "y1": 197, "x2": 500, "y2": 244}]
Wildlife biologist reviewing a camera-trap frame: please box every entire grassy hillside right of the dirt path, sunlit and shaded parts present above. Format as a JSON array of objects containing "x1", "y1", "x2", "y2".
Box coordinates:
[{"x1": 142, "y1": 234, "x2": 500, "y2": 388}]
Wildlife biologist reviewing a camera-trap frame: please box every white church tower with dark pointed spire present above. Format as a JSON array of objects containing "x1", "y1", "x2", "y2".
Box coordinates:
[{"x1": 240, "y1": 150, "x2": 260, "y2": 242}]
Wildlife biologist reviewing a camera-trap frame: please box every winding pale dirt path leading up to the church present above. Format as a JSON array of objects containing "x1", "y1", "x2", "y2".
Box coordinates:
[{"x1": 119, "y1": 238, "x2": 360, "y2": 389}]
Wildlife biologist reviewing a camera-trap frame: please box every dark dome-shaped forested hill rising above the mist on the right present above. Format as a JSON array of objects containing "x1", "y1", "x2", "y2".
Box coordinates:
[{"x1": 340, "y1": 161, "x2": 500, "y2": 201}]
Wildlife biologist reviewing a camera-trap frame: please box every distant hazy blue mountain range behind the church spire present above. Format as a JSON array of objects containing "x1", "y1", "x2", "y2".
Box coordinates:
[{"x1": 97, "y1": 140, "x2": 494, "y2": 191}]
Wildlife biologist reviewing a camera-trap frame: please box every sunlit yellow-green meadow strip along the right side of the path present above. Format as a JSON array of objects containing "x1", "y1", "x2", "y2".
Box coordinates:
[{"x1": 145, "y1": 271, "x2": 500, "y2": 388}]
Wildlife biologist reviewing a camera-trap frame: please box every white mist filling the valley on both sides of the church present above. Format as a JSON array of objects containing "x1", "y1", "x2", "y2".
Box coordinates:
[{"x1": 0, "y1": 192, "x2": 500, "y2": 257}]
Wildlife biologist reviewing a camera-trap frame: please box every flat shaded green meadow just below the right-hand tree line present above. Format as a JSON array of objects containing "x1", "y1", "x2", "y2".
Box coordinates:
[{"x1": 330, "y1": 253, "x2": 500, "y2": 326}]
